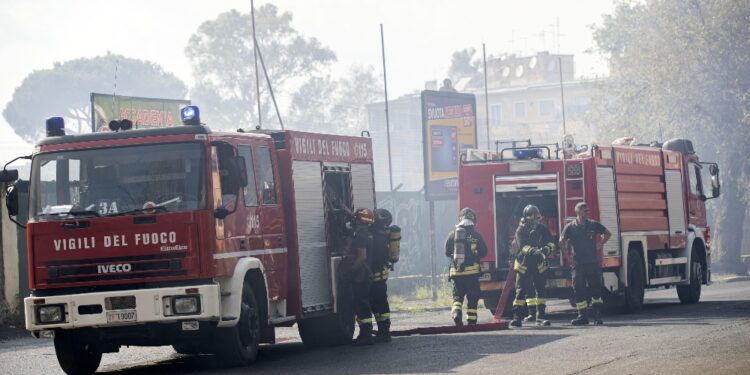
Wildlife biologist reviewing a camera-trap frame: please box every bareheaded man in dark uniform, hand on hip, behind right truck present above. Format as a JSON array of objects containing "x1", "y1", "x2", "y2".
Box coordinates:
[{"x1": 560, "y1": 202, "x2": 612, "y2": 326}]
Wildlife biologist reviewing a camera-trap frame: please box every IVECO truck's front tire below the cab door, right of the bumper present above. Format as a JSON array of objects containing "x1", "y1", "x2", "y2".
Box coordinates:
[{"x1": 215, "y1": 281, "x2": 261, "y2": 367}]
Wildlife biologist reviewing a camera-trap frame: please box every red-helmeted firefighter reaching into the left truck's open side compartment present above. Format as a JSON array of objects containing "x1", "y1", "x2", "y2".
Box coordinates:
[{"x1": 350, "y1": 208, "x2": 375, "y2": 346}]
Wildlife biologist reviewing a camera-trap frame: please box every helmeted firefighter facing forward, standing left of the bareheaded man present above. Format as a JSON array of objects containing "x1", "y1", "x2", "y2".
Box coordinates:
[{"x1": 510, "y1": 204, "x2": 555, "y2": 327}]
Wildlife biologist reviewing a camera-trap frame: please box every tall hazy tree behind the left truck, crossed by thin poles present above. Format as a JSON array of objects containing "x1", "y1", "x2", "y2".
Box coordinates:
[{"x1": 185, "y1": 4, "x2": 336, "y2": 129}]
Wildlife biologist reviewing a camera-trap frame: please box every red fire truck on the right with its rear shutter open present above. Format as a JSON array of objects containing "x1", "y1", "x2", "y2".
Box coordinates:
[{"x1": 459, "y1": 139, "x2": 720, "y2": 313}]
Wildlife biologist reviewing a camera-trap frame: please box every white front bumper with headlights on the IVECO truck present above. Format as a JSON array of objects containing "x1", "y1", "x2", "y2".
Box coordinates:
[{"x1": 24, "y1": 285, "x2": 221, "y2": 332}]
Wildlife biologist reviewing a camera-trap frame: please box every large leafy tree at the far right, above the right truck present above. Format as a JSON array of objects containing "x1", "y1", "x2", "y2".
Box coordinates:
[{"x1": 593, "y1": 0, "x2": 750, "y2": 272}]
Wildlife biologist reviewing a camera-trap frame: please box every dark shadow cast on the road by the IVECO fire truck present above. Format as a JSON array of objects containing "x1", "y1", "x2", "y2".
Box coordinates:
[{"x1": 100, "y1": 333, "x2": 568, "y2": 374}]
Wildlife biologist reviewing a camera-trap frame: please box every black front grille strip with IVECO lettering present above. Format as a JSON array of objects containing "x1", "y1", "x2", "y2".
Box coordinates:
[{"x1": 46, "y1": 253, "x2": 187, "y2": 284}]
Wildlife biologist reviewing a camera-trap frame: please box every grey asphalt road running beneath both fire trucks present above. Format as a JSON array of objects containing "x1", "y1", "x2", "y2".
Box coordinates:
[{"x1": 0, "y1": 281, "x2": 750, "y2": 375}]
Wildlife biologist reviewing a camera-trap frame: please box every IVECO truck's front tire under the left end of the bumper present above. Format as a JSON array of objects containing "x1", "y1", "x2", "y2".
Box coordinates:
[{"x1": 55, "y1": 329, "x2": 102, "y2": 375}]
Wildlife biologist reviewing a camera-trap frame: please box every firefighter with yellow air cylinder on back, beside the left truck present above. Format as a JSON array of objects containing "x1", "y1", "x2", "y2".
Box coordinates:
[{"x1": 367, "y1": 208, "x2": 393, "y2": 342}]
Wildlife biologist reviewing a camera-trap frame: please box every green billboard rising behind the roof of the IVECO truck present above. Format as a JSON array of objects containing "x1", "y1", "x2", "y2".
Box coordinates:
[{"x1": 91, "y1": 92, "x2": 190, "y2": 132}]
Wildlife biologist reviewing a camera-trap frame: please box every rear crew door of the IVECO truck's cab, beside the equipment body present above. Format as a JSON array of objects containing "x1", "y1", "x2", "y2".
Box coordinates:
[{"x1": 255, "y1": 145, "x2": 287, "y2": 299}]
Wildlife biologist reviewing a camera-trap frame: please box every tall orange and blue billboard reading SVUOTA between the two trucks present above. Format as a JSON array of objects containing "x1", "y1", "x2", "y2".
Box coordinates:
[{"x1": 422, "y1": 90, "x2": 477, "y2": 200}]
